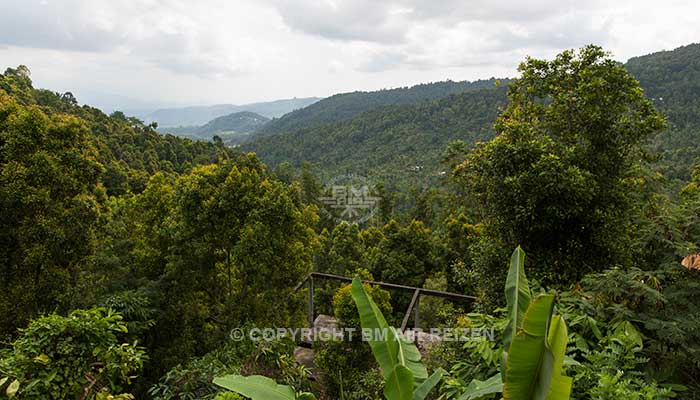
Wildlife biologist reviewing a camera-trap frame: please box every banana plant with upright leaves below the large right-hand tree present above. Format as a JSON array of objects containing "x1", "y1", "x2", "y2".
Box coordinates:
[{"x1": 459, "y1": 246, "x2": 572, "y2": 400}]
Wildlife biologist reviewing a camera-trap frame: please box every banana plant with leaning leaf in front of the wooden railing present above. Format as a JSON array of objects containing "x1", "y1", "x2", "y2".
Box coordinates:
[{"x1": 351, "y1": 278, "x2": 443, "y2": 400}]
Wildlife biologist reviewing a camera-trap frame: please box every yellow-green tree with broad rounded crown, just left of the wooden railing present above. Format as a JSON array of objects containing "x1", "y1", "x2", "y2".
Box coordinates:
[{"x1": 144, "y1": 155, "x2": 317, "y2": 366}]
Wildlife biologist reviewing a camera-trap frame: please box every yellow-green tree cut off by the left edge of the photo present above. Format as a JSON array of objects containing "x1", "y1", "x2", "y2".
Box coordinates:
[{"x1": 0, "y1": 91, "x2": 102, "y2": 334}]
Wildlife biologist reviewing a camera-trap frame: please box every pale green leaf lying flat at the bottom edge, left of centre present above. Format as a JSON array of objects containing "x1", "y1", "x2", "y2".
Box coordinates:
[{"x1": 214, "y1": 375, "x2": 295, "y2": 400}]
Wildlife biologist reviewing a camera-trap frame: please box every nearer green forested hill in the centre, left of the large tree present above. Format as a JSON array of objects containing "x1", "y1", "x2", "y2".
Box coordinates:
[{"x1": 243, "y1": 86, "x2": 506, "y2": 186}]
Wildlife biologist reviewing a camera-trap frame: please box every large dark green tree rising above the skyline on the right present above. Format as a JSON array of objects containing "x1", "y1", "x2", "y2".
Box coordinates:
[{"x1": 455, "y1": 45, "x2": 665, "y2": 292}]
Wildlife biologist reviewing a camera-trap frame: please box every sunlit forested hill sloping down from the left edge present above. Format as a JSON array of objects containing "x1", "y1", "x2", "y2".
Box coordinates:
[{"x1": 0, "y1": 66, "x2": 234, "y2": 195}]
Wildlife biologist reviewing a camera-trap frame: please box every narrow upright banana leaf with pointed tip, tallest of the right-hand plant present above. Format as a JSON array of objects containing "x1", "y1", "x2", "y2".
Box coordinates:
[{"x1": 503, "y1": 246, "x2": 532, "y2": 352}]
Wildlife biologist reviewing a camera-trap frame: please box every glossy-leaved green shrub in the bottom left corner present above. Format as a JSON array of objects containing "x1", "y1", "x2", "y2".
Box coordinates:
[{"x1": 0, "y1": 308, "x2": 146, "y2": 399}]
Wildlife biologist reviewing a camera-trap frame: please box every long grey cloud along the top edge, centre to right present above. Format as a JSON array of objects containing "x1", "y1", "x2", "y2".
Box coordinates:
[{"x1": 269, "y1": 0, "x2": 597, "y2": 44}]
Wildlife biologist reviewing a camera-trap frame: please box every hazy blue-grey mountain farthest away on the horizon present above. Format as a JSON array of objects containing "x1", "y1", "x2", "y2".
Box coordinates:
[{"x1": 146, "y1": 97, "x2": 321, "y2": 127}]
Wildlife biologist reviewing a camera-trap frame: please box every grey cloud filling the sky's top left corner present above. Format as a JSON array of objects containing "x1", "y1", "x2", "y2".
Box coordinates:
[{"x1": 0, "y1": 0, "x2": 252, "y2": 77}]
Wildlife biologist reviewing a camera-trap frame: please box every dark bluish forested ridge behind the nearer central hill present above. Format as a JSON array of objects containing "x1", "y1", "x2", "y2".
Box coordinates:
[{"x1": 260, "y1": 78, "x2": 507, "y2": 134}]
